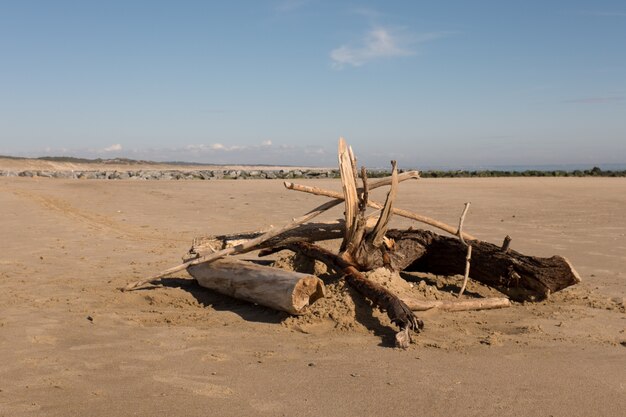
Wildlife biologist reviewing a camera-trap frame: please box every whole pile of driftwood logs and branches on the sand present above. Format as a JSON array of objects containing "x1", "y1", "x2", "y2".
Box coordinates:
[{"x1": 125, "y1": 139, "x2": 580, "y2": 347}]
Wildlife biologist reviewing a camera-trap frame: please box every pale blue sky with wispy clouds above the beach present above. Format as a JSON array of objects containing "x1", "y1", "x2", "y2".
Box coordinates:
[{"x1": 0, "y1": 0, "x2": 626, "y2": 168}]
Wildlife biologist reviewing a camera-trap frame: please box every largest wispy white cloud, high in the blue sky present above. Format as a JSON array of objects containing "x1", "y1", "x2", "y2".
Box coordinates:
[{"x1": 330, "y1": 26, "x2": 445, "y2": 69}]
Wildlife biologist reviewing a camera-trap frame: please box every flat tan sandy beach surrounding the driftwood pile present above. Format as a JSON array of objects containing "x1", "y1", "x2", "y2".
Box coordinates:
[{"x1": 0, "y1": 174, "x2": 626, "y2": 417}]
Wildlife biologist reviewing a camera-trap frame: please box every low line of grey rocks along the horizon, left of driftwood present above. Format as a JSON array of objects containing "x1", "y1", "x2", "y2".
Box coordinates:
[{"x1": 0, "y1": 169, "x2": 339, "y2": 180}]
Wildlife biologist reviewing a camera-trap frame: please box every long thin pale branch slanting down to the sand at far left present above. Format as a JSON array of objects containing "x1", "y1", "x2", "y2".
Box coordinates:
[{"x1": 124, "y1": 200, "x2": 343, "y2": 291}]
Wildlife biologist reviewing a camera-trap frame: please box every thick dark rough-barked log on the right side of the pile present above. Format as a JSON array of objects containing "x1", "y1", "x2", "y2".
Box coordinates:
[{"x1": 366, "y1": 230, "x2": 580, "y2": 300}]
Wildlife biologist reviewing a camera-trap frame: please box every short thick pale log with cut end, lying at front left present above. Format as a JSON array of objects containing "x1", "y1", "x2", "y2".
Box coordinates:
[{"x1": 187, "y1": 258, "x2": 324, "y2": 315}]
